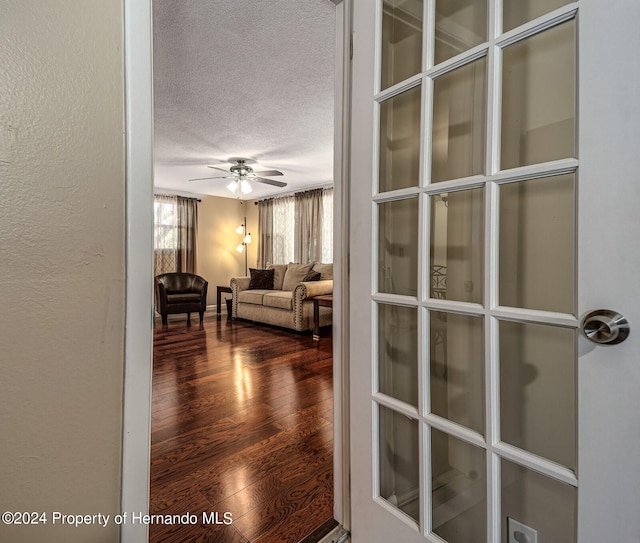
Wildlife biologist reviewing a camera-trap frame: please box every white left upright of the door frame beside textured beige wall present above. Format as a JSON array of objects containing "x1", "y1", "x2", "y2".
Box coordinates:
[{"x1": 120, "y1": 0, "x2": 154, "y2": 543}]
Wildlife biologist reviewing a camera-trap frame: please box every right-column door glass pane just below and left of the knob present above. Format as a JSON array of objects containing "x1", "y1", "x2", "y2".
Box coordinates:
[{"x1": 499, "y1": 321, "x2": 577, "y2": 470}]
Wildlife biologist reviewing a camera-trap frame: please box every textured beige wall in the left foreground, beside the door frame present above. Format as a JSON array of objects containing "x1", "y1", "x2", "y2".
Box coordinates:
[{"x1": 0, "y1": 0, "x2": 125, "y2": 543}]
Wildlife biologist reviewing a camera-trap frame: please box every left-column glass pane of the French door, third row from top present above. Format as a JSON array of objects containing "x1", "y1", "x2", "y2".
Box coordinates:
[{"x1": 378, "y1": 198, "x2": 418, "y2": 296}]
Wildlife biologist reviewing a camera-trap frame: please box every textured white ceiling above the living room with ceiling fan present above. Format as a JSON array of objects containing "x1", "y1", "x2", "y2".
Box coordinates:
[{"x1": 153, "y1": 0, "x2": 336, "y2": 199}]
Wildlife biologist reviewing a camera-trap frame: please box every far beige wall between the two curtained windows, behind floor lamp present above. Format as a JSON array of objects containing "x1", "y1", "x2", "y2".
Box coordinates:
[{"x1": 197, "y1": 196, "x2": 258, "y2": 305}]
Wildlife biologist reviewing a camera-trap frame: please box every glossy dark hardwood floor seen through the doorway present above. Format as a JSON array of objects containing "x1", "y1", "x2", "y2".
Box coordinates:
[{"x1": 149, "y1": 314, "x2": 333, "y2": 543}]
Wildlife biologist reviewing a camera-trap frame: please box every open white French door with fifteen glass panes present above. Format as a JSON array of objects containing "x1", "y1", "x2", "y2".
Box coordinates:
[{"x1": 350, "y1": 0, "x2": 640, "y2": 543}]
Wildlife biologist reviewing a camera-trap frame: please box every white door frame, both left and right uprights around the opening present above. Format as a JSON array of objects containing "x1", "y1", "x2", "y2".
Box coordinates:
[{"x1": 120, "y1": 0, "x2": 352, "y2": 543}]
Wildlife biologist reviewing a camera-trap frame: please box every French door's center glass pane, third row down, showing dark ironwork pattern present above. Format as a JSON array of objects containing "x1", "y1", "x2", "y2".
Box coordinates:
[{"x1": 429, "y1": 188, "x2": 484, "y2": 304}]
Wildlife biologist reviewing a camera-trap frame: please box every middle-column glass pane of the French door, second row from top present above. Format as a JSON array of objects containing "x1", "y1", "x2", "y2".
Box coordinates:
[{"x1": 431, "y1": 57, "x2": 487, "y2": 183}]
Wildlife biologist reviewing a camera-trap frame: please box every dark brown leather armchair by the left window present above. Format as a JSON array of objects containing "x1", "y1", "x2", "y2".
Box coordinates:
[{"x1": 155, "y1": 272, "x2": 209, "y2": 324}]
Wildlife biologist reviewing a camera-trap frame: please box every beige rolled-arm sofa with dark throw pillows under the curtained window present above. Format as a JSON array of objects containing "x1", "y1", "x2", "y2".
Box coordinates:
[{"x1": 231, "y1": 262, "x2": 333, "y2": 332}]
